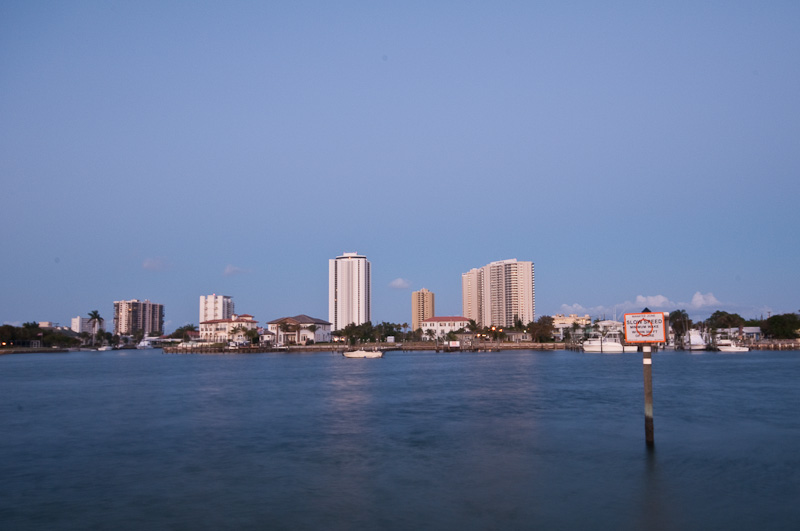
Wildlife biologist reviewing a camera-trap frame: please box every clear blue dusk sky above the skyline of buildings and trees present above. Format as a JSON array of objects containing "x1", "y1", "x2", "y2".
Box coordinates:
[{"x1": 0, "y1": 1, "x2": 800, "y2": 331}]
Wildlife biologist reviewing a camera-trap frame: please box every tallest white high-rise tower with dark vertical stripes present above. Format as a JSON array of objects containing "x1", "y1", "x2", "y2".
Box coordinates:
[{"x1": 328, "y1": 253, "x2": 372, "y2": 330}]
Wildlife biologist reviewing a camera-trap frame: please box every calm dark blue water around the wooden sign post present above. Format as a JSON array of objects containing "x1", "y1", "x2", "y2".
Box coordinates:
[{"x1": 0, "y1": 350, "x2": 800, "y2": 530}]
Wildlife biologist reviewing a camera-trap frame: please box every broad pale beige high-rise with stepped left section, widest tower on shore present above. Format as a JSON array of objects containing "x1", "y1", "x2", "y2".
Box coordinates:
[{"x1": 461, "y1": 258, "x2": 536, "y2": 327}]
